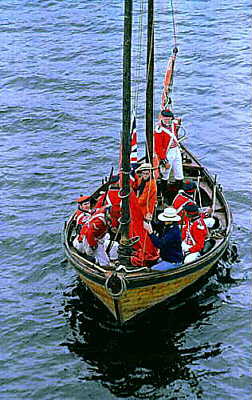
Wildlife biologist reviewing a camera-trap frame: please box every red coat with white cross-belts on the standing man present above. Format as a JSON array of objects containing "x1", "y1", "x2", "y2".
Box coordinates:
[{"x1": 154, "y1": 120, "x2": 179, "y2": 160}]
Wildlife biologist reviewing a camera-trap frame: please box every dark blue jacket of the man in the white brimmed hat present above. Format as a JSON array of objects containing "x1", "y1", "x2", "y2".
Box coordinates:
[{"x1": 149, "y1": 223, "x2": 183, "y2": 263}]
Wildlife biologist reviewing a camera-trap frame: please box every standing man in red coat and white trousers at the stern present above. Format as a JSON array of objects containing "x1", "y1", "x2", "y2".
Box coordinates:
[{"x1": 154, "y1": 110, "x2": 184, "y2": 195}]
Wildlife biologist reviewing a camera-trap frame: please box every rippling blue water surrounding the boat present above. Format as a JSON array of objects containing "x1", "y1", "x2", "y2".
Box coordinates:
[{"x1": 0, "y1": 0, "x2": 252, "y2": 400}]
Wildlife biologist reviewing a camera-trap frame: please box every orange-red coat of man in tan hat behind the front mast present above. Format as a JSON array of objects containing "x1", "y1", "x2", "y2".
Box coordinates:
[{"x1": 132, "y1": 176, "x2": 157, "y2": 217}]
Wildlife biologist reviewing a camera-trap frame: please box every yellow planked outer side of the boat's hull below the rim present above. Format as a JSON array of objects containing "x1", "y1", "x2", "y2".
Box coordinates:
[{"x1": 64, "y1": 228, "x2": 228, "y2": 324}]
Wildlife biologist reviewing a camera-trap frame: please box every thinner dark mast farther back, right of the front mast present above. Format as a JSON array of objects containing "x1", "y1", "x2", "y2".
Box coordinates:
[{"x1": 146, "y1": 0, "x2": 154, "y2": 163}]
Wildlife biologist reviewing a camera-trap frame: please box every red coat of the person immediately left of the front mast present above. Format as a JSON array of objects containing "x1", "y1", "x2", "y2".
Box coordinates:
[{"x1": 96, "y1": 188, "x2": 121, "y2": 228}]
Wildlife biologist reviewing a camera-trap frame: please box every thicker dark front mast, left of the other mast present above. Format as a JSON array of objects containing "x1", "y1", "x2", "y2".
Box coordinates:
[{"x1": 121, "y1": 0, "x2": 133, "y2": 245}]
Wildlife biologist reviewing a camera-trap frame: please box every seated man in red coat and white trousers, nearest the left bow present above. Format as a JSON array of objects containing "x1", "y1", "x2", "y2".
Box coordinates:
[{"x1": 73, "y1": 207, "x2": 111, "y2": 265}]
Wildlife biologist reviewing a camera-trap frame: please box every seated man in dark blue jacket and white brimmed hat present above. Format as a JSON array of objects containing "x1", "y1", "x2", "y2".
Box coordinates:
[{"x1": 144, "y1": 207, "x2": 183, "y2": 271}]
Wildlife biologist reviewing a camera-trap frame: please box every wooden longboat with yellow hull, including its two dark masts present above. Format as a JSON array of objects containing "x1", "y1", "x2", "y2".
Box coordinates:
[{"x1": 63, "y1": 0, "x2": 232, "y2": 324}]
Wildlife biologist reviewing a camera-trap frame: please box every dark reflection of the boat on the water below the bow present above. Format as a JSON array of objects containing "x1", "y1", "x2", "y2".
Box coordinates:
[{"x1": 62, "y1": 281, "x2": 228, "y2": 398}]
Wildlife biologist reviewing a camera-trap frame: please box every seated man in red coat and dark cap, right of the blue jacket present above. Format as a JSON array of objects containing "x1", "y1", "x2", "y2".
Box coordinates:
[{"x1": 182, "y1": 203, "x2": 208, "y2": 263}]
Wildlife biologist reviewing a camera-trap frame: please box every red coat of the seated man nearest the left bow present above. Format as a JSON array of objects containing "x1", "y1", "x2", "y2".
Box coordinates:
[{"x1": 78, "y1": 207, "x2": 108, "y2": 247}]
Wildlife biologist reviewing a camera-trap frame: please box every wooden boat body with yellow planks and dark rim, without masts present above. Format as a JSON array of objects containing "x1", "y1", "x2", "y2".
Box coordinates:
[{"x1": 64, "y1": 147, "x2": 232, "y2": 324}]
